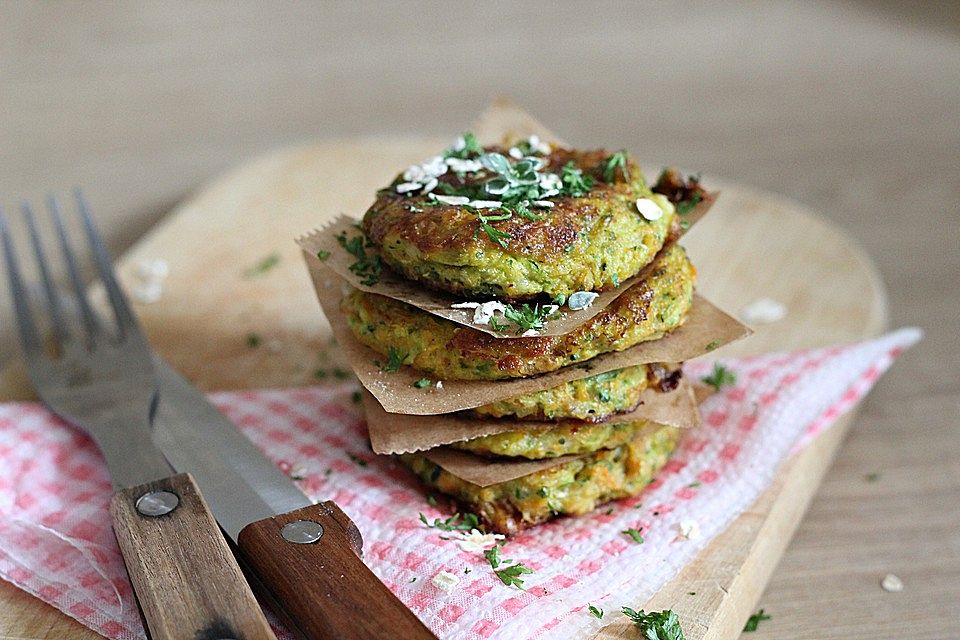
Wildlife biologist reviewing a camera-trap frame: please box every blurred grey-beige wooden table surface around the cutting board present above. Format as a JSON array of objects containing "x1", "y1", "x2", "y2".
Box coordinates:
[{"x1": 0, "y1": 0, "x2": 960, "y2": 640}]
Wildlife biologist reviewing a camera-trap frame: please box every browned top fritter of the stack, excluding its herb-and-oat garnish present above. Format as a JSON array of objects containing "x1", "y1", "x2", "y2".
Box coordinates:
[{"x1": 362, "y1": 147, "x2": 676, "y2": 301}]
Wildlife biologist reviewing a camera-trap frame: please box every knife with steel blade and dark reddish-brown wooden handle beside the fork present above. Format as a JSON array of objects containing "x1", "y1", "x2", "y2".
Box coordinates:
[{"x1": 153, "y1": 358, "x2": 436, "y2": 640}]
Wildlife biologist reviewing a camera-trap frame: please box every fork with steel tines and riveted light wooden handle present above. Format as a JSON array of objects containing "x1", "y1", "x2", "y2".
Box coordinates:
[{"x1": 0, "y1": 189, "x2": 276, "y2": 640}]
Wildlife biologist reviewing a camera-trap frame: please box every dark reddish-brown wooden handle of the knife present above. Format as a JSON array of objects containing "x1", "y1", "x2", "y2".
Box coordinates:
[{"x1": 238, "y1": 502, "x2": 436, "y2": 640}]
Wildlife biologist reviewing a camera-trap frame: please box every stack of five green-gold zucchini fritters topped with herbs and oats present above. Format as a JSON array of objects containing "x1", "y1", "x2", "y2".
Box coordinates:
[{"x1": 341, "y1": 134, "x2": 703, "y2": 533}]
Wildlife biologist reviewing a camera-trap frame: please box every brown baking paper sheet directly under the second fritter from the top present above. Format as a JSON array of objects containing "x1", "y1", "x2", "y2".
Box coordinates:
[{"x1": 307, "y1": 255, "x2": 750, "y2": 415}]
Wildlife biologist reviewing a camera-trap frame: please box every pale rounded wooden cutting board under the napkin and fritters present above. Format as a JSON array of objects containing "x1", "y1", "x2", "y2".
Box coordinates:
[{"x1": 0, "y1": 103, "x2": 886, "y2": 640}]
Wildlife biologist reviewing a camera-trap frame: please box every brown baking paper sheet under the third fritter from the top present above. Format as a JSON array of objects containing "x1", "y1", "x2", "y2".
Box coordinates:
[{"x1": 363, "y1": 378, "x2": 700, "y2": 455}]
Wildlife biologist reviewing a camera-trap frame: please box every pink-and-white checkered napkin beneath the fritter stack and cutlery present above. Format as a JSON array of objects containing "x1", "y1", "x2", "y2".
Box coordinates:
[{"x1": 0, "y1": 329, "x2": 920, "y2": 638}]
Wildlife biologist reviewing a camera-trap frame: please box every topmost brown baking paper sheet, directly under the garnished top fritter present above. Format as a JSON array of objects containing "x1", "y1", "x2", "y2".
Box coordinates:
[{"x1": 297, "y1": 192, "x2": 719, "y2": 339}]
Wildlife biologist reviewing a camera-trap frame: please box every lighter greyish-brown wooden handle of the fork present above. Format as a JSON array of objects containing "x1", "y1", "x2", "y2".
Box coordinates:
[{"x1": 110, "y1": 473, "x2": 276, "y2": 640}]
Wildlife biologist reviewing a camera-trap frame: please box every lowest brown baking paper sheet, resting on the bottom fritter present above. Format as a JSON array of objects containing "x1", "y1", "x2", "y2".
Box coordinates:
[{"x1": 421, "y1": 416, "x2": 676, "y2": 487}]
